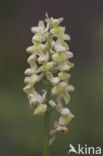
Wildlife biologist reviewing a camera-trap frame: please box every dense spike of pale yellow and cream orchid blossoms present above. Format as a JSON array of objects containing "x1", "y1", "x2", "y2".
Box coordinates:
[{"x1": 24, "y1": 15, "x2": 74, "y2": 140}]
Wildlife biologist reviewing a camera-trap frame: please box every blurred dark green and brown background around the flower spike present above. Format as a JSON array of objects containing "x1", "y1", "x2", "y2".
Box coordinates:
[{"x1": 0, "y1": 0, "x2": 103, "y2": 156}]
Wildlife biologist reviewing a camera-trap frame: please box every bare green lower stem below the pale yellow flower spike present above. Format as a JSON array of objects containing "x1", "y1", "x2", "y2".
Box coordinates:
[{"x1": 43, "y1": 112, "x2": 50, "y2": 156}]
